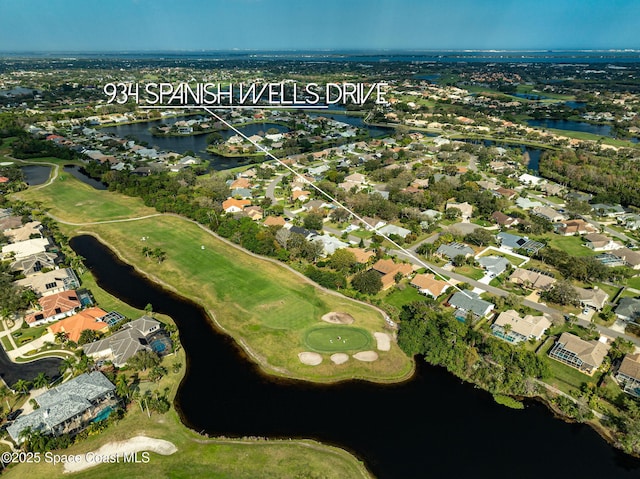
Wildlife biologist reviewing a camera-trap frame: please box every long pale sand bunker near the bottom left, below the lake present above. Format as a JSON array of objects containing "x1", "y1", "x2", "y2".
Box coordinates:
[{"x1": 64, "y1": 436, "x2": 178, "y2": 474}]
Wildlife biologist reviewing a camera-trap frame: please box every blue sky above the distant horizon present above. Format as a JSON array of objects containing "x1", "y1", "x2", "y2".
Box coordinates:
[{"x1": 0, "y1": 0, "x2": 640, "y2": 52}]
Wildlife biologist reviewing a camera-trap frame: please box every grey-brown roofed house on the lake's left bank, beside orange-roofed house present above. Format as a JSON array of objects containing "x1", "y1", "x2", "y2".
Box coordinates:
[{"x1": 82, "y1": 316, "x2": 161, "y2": 367}]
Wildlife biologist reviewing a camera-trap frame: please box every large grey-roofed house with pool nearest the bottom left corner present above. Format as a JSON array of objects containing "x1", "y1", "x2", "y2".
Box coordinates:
[{"x1": 7, "y1": 371, "x2": 118, "y2": 444}]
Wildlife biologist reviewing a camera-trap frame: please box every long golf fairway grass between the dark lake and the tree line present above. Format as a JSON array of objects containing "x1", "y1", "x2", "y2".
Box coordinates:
[{"x1": 20, "y1": 177, "x2": 413, "y2": 381}]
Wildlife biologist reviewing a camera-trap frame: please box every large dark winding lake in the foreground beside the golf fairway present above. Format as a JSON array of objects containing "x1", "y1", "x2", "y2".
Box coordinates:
[{"x1": 71, "y1": 236, "x2": 640, "y2": 479}]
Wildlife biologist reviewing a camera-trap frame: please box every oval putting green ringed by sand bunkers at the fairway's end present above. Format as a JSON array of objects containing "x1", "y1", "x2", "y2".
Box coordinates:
[{"x1": 304, "y1": 326, "x2": 373, "y2": 353}]
